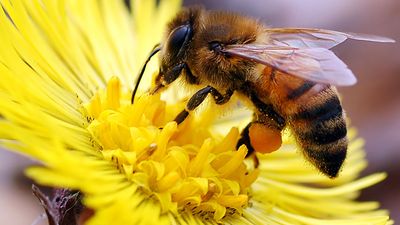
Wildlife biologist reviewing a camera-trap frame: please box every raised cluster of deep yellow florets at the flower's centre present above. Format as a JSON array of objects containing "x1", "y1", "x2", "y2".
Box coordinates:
[{"x1": 86, "y1": 77, "x2": 258, "y2": 220}]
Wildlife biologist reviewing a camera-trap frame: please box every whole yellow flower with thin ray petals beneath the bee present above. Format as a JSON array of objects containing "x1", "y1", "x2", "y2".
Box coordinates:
[{"x1": 0, "y1": 0, "x2": 392, "y2": 225}]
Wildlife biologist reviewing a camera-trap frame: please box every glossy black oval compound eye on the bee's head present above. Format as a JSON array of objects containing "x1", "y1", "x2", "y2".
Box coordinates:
[{"x1": 167, "y1": 25, "x2": 191, "y2": 55}]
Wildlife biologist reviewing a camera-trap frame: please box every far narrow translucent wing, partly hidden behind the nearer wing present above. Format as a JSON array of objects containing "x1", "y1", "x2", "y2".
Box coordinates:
[{"x1": 266, "y1": 28, "x2": 395, "y2": 49}]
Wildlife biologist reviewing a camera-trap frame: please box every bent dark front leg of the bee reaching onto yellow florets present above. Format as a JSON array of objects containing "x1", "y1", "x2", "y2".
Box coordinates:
[{"x1": 175, "y1": 86, "x2": 233, "y2": 124}]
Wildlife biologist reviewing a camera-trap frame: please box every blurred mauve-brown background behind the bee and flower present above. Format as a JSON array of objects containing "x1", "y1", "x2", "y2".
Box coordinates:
[{"x1": 0, "y1": 0, "x2": 400, "y2": 225}]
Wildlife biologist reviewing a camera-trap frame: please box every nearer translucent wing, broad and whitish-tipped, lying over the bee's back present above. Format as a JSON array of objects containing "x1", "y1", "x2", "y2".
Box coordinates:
[{"x1": 221, "y1": 44, "x2": 357, "y2": 86}]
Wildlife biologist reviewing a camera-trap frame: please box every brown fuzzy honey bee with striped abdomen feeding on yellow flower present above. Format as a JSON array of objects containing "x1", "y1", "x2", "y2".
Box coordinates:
[{"x1": 132, "y1": 7, "x2": 393, "y2": 178}]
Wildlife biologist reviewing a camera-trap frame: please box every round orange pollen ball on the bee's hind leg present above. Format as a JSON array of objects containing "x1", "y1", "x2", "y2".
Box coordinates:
[{"x1": 249, "y1": 123, "x2": 282, "y2": 153}]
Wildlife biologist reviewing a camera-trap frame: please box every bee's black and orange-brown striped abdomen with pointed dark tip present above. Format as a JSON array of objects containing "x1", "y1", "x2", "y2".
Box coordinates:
[{"x1": 282, "y1": 81, "x2": 347, "y2": 177}]
